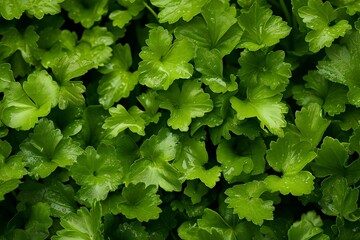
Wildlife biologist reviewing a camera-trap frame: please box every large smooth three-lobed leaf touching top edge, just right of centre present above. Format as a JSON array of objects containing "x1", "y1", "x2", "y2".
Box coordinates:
[{"x1": 175, "y1": 0, "x2": 242, "y2": 57}]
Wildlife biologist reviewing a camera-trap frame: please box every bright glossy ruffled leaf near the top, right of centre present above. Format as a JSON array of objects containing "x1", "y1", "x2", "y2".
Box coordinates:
[{"x1": 238, "y1": 2, "x2": 291, "y2": 51}]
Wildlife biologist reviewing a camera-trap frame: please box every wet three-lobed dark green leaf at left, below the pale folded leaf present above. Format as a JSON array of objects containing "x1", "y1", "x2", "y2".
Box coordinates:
[{"x1": 20, "y1": 119, "x2": 82, "y2": 179}]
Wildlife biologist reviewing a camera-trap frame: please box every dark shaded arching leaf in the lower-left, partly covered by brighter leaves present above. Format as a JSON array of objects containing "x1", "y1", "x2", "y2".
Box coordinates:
[{"x1": 16, "y1": 177, "x2": 77, "y2": 218}]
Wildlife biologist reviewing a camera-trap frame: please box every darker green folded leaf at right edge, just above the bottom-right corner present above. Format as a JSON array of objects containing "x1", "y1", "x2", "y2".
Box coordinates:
[{"x1": 319, "y1": 177, "x2": 359, "y2": 222}]
